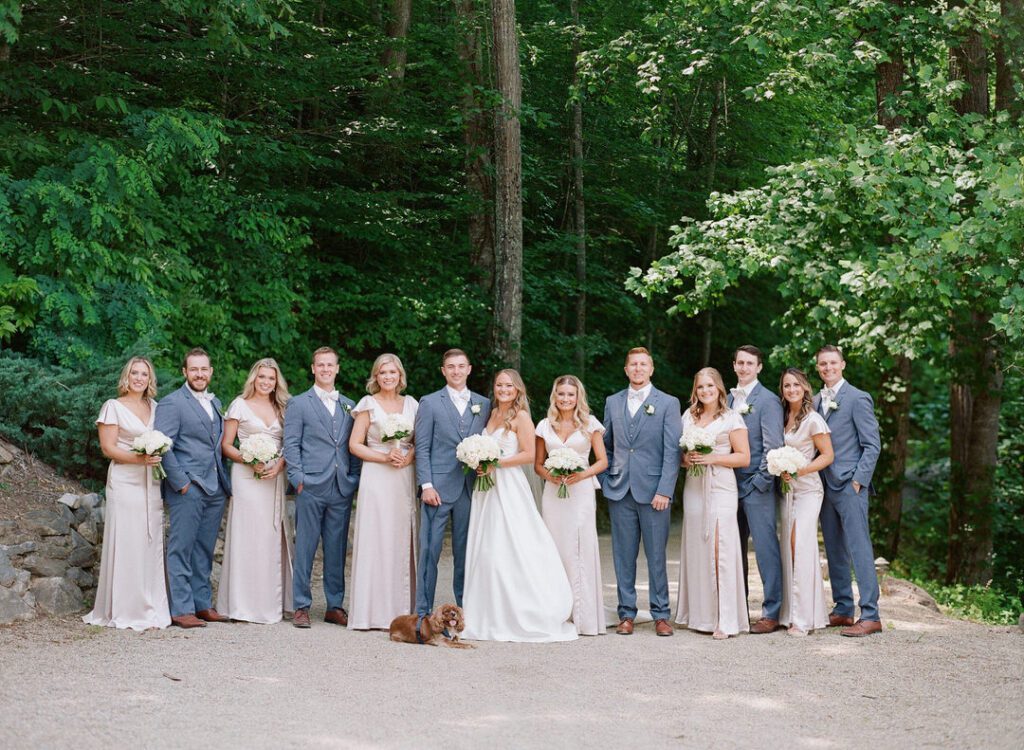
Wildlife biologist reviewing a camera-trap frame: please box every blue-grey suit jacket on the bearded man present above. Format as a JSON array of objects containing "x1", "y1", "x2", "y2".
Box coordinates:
[{"x1": 153, "y1": 383, "x2": 231, "y2": 495}]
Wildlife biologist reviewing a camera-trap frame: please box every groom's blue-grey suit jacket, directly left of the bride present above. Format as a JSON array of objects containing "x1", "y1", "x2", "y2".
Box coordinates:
[{"x1": 414, "y1": 388, "x2": 490, "y2": 503}]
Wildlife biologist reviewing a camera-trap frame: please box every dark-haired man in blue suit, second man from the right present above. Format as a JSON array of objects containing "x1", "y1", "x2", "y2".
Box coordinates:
[{"x1": 728, "y1": 344, "x2": 784, "y2": 633}]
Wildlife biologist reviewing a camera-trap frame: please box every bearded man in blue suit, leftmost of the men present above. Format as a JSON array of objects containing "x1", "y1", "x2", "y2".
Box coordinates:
[{"x1": 154, "y1": 348, "x2": 231, "y2": 628}]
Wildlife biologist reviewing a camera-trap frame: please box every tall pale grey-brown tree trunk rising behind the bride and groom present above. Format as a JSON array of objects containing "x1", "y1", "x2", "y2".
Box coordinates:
[{"x1": 490, "y1": 0, "x2": 522, "y2": 369}]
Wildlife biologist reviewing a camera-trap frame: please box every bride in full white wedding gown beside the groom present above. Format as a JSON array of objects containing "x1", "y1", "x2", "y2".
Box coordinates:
[{"x1": 463, "y1": 370, "x2": 578, "y2": 643}]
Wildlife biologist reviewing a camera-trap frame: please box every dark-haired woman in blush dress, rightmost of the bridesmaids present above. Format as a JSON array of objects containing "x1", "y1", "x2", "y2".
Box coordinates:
[{"x1": 779, "y1": 367, "x2": 835, "y2": 635}]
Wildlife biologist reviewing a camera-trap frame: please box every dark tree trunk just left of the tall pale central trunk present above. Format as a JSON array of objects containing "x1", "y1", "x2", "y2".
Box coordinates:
[{"x1": 456, "y1": 0, "x2": 495, "y2": 297}]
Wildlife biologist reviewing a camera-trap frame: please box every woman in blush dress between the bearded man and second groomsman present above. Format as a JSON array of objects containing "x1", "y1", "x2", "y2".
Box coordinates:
[{"x1": 217, "y1": 358, "x2": 292, "y2": 624}]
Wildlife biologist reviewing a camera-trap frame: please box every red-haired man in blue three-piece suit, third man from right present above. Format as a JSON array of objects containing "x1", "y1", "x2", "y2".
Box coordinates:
[{"x1": 601, "y1": 346, "x2": 682, "y2": 635}]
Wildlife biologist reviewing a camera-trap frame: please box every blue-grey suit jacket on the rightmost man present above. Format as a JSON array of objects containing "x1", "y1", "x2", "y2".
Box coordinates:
[{"x1": 814, "y1": 382, "x2": 882, "y2": 492}]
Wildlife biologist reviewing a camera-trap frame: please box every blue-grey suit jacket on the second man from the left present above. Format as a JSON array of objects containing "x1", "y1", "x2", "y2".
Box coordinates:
[{"x1": 285, "y1": 388, "x2": 362, "y2": 497}]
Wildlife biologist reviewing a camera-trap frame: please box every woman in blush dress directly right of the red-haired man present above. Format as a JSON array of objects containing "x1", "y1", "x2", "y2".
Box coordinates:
[{"x1": 676, "y1": 367, "x2": 751, "y2": 640}]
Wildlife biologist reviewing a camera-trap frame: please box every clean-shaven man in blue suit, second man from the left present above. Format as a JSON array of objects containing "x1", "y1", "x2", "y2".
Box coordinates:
[{"x1": 285, "y1": 346, "x2": 362, "y2": 628}]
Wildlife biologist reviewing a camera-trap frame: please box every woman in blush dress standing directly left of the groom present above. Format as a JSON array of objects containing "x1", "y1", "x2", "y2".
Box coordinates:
[{"x1": 348, "y1": 353, "x2": 419, "y2": 630}]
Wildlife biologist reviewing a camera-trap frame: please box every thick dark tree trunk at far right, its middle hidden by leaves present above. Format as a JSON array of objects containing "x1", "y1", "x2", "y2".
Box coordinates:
[{"x1": 946, "y1": 16, "x2": 1002, "y2": 584}]
